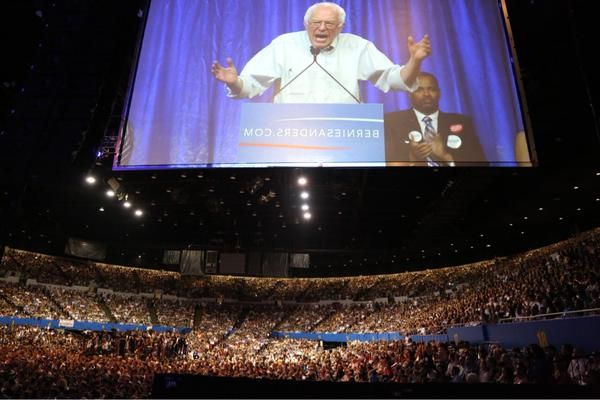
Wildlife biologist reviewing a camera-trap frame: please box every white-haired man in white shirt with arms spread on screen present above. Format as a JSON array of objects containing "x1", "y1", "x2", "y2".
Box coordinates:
[{"x1": 211, "y1": 2, "x2": 431, "y2": 103}]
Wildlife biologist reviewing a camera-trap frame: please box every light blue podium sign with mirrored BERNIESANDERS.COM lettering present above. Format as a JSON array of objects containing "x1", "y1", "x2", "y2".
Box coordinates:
[{"x1": 237, "y1": 103, "x2": 385, "y2": 167}]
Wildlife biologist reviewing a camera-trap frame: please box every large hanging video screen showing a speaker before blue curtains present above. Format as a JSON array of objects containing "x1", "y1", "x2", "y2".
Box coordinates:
[{"x1": 114, "y1": 0, "x2": 534, "y2": 169}]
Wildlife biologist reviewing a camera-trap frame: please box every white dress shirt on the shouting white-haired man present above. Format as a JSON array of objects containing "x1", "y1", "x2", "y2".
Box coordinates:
[{"x1": 228, "y1": 31, "x2": 417, "y2": 103}]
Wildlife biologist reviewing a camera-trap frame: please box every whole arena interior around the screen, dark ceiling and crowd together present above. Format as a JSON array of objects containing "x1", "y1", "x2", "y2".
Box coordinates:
[{"x1": 0, "y1": 0, "x2": 600, "y2": 398}]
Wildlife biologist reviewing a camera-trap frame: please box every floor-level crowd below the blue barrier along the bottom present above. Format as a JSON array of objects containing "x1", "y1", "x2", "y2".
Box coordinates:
[{"x1": 0, "y1": 326, "x2": 600, "y2": 398}]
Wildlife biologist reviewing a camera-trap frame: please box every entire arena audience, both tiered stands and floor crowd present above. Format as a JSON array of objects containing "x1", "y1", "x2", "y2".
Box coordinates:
[{"x1": 0, "y1": 231, "x2": 600, "y2": 397}]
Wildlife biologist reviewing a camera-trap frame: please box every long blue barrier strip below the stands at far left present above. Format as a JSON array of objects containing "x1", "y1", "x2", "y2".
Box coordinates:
[{"x1": 0, "y1": 317, "x2": 192, "y2": 333}]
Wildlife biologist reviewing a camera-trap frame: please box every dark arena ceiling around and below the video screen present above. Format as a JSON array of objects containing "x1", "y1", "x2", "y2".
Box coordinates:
[{"x1": 0, "y1": 0, "x2": 600, "y2": 275}]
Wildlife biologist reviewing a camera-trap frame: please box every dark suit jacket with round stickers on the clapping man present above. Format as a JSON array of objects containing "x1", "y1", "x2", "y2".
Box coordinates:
[{"x1": 385, "y1": 109, "x2": 487, "y2": 166}]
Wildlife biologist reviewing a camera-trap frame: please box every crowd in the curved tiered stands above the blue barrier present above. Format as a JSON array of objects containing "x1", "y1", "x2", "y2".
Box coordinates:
[{"x1": 0, "y1": 227, "x2": 600, "y2": 334}]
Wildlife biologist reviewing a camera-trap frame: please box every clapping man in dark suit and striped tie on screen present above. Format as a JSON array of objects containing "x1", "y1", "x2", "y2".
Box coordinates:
[{"x1": 385, "y1": 72, "x2": 487, "y2": 166}]
